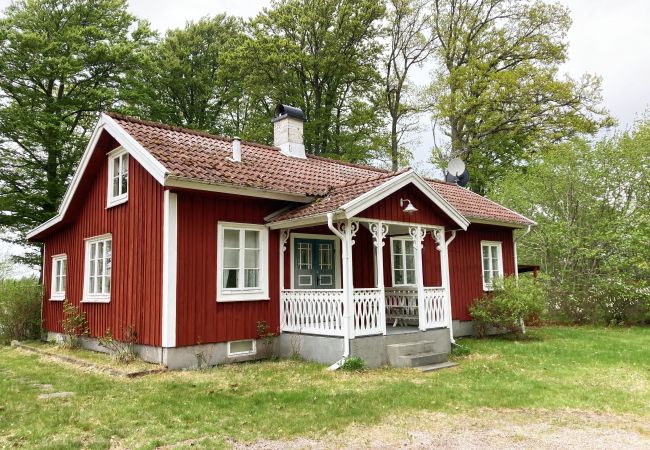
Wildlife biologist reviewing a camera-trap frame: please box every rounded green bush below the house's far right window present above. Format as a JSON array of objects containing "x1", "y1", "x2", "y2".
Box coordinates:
[{"x1": 469, "y1": 277, "x2": 546, "y2": 337}]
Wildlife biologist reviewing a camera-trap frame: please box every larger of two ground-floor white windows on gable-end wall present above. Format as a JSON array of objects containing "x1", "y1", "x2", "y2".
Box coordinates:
[{"x1": 83, "y1": 235, "x2": 113, "y2": 302}]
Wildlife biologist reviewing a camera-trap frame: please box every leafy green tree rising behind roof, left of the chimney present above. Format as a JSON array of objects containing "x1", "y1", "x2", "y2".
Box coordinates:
[{"x1": 124, "y1": 14, "x2": 253, "y2": 135}]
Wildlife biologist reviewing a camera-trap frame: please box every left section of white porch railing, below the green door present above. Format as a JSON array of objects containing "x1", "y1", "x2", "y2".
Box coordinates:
[{"x1": 280, "y1": 289, "x2": 344, "y2": 336}]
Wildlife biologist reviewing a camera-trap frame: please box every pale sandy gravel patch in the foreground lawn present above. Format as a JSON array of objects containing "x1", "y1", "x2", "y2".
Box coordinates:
[{"x1": 229, "y1": 409, "x2": 650, "y2": 450}]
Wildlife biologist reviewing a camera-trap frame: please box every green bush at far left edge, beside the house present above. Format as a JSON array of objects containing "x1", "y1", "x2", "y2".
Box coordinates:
[{"x1": 0, "y1": 278, "x2": 43, "y2": 344}]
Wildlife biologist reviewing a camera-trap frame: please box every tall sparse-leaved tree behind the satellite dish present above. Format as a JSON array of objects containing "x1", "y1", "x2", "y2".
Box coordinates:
[{"x1": 429, "y1": 0, "x2": 612, "y2": 193}]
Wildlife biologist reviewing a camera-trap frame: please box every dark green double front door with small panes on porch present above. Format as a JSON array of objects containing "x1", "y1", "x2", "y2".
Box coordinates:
[{"x1": 293, "y1": 238, "x2": 336, "y2": 289}]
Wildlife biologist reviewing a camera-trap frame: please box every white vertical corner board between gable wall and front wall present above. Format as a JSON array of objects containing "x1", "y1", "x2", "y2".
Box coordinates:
[{"x1": 162, "y1": 190, "x2": 178, "y2": 347}]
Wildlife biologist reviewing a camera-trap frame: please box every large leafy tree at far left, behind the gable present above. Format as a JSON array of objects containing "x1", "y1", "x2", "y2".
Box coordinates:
[{"x1": 0, "y1": 0, "x2": 151, "y2": 266}]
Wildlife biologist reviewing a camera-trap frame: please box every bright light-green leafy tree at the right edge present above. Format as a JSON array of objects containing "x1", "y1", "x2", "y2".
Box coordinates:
[{"x1": 493, "y1": 122, "x2": 650, "y2": 322}]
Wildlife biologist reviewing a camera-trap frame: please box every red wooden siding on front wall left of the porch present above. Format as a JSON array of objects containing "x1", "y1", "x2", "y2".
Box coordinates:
[{"x1": 176, "y1": 191, "x2": 284, "y2": 347}]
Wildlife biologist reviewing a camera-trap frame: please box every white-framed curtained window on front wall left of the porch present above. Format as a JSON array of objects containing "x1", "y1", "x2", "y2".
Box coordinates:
[{"x1": 217, "y1": 223, "x2": 268, "y2": 301}]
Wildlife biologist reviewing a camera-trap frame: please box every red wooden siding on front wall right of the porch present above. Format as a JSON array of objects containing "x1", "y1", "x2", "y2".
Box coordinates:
[{"x1": 449, "y1": 225, "x2": 515, "y2": 320}]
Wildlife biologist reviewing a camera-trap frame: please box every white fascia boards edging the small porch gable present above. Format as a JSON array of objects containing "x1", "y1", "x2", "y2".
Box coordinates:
[{"x1": 340, "y1": 170, "x2": 470, "y2": 230}]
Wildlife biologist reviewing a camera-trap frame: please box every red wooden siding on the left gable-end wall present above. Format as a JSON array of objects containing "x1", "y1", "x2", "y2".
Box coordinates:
[{"x1": 43, "y1": 134, "x2": 163, "y2": 345}]
